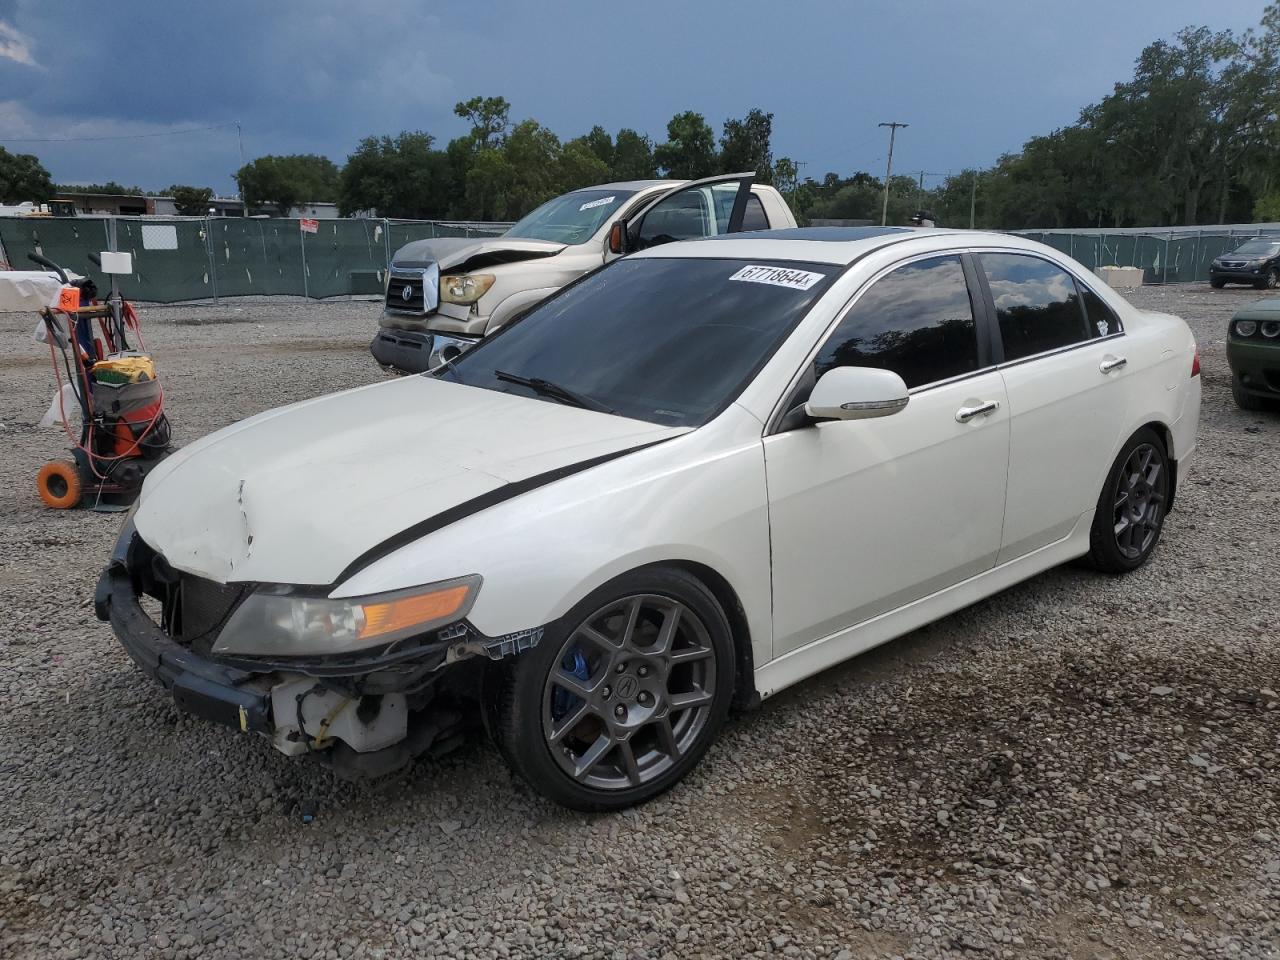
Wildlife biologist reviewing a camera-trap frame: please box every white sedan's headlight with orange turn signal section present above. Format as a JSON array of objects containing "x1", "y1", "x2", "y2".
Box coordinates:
[{"x1": 214, "y1": 575, "x2": 480, "y2": 657}]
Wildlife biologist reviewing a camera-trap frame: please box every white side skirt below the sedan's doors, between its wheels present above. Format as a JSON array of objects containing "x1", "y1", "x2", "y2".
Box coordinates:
[{"x1": 755, "y1": 509, "x2": 1093, "y2": 699}]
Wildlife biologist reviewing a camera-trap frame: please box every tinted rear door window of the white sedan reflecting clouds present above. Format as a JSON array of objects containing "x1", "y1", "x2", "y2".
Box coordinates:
[{"x1": 978, "y1": 253, "x2": 1089, "y2": 360}]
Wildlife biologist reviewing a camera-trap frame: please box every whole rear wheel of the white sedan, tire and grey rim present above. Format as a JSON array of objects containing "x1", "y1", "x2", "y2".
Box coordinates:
[{"x1": 1089, "y1": 428, "x2": 1170, "y2": 573}]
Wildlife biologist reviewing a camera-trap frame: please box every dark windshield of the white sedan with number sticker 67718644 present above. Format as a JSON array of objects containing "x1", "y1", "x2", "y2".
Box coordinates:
[{"x1": 436, "y1": 257, "x2": 840, "y2": 426}]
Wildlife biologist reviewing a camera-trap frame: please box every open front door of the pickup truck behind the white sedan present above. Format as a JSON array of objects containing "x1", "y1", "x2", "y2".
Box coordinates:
[{"x1": 605, "y1": 173, "x2": 755, "y2": 259}]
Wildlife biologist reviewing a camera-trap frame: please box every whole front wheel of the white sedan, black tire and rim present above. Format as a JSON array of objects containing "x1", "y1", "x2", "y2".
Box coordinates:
[{"x1": 493, "y1": 567, "x2": 735, "y2": 810}]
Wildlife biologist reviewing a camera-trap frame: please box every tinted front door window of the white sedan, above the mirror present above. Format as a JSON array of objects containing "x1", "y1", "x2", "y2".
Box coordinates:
[{"x1": 817, "y1": 256, "x2": 978, "y2": 387}]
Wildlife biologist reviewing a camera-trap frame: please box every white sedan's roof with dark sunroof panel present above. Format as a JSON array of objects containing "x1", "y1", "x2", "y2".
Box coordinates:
[{"x1": 632, "y1": 227, "x2": 1044, "y2": 266}]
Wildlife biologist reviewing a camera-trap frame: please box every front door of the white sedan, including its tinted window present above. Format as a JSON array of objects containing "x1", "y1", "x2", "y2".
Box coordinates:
[{"x1": 764, "y1": 255, "x2": 1009, "y2": 657}]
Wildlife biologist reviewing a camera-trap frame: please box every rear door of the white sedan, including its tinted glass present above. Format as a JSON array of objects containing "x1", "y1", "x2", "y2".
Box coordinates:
[{"x1": 974, "y1": 251, "x2": 1132, "y2": 563}]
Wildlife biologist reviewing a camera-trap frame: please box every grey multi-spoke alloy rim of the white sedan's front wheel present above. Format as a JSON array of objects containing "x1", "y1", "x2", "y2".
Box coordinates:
[{"x1": 541, "y1": 594, "x2": 717, "y2": 790}]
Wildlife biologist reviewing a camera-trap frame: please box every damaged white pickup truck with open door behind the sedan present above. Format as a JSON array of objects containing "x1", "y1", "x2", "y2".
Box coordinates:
[{"x1": 370, "y1": 173, "x2": 796, "y2": 372}]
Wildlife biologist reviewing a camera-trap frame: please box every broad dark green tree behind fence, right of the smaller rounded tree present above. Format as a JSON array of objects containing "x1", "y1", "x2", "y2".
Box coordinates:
[{"x1": 338, "y1": 131, "x2": 456, "y2": 220}]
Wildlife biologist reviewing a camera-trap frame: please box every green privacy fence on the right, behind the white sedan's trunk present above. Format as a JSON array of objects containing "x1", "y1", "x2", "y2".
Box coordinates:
[{"x1": 1016, "y1": 224, "x2": 1280, "y2": 283}]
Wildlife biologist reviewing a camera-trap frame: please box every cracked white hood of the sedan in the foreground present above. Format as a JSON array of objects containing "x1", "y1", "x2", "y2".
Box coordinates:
[{"x1": 134, "y1": 376, "x2": 689, "y2": 585}]
